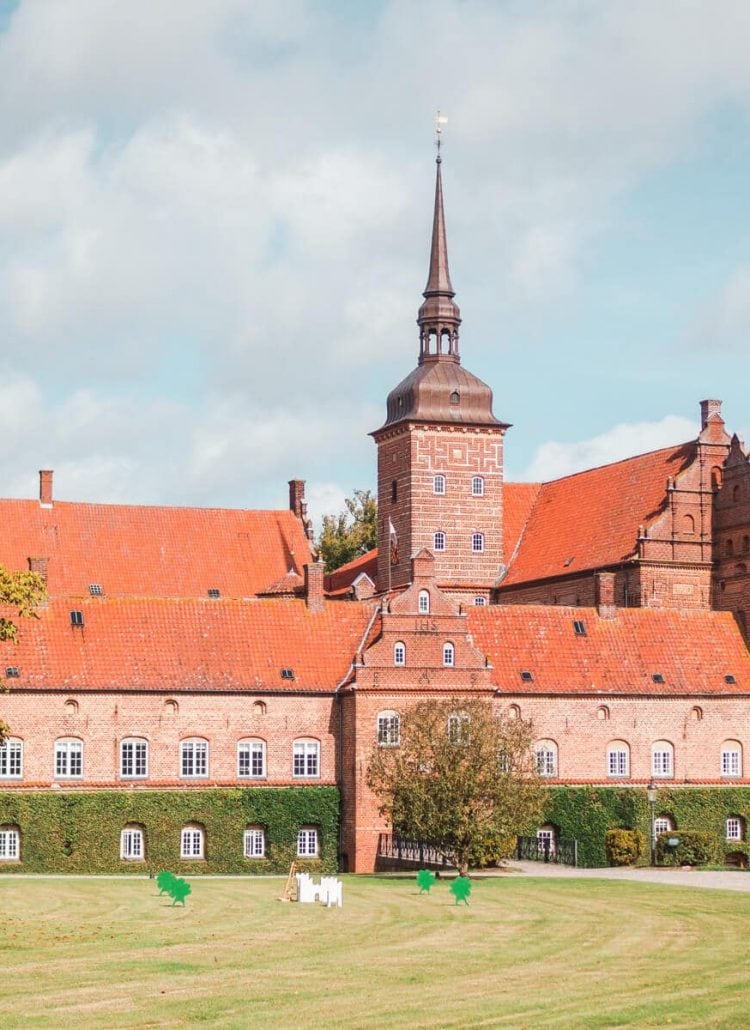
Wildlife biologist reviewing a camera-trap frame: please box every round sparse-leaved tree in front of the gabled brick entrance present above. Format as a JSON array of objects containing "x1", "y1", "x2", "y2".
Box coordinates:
[{"x1": 368, "y1": 698, "x2": 545, "y2": 876}]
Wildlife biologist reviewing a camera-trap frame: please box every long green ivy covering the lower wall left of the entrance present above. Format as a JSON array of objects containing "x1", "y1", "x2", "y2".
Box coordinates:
[{"x1": 0, "y1": 787, "x2": 339, "y2": 876}]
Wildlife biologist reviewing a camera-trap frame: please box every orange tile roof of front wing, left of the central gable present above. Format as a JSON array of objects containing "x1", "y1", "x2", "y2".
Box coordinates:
[{"x1": 0, "y1": 598, "x2": 374, "y2": 693}]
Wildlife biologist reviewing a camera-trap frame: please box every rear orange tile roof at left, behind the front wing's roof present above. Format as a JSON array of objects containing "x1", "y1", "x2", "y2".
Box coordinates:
[{"x1": 0, "y1": 501, "x2": 310, "y2": 597}]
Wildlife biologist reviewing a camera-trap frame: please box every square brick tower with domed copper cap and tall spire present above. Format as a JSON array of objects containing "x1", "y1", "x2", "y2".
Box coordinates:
[{"x1": 372, "y1": 151, "x2": 508, "y2": 603}]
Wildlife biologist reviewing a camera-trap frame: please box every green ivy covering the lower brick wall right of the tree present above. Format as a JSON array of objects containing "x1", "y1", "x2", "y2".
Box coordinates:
[{"x1": 545, "y1": 786, "x2": 750, "y2": 866}]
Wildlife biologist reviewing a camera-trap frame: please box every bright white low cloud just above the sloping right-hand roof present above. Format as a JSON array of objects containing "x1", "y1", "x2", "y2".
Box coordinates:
[{"x1": 522, "y1": 415, "x2": 698, "y2": 482}]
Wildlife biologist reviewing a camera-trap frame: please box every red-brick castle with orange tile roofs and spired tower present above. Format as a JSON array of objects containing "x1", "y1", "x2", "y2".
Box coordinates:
[{"x1": 0, "y1": 158, "x2": 750, "y2": 872}]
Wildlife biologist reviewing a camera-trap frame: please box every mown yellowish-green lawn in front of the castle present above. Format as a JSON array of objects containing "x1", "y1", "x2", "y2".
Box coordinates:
[{"x1": 0, "y1": 874, "x2": 750, "y2": 1028}]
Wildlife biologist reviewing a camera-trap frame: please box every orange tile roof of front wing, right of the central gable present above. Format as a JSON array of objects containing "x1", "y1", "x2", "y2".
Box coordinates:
[{"x1": 468, "y1": 605, "x2": 750, "y2": 696}]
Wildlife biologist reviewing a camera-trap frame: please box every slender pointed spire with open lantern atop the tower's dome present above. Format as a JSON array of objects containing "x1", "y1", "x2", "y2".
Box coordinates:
[{"x1": 417, "y1": 152, "x2": 461, "y2": 365}]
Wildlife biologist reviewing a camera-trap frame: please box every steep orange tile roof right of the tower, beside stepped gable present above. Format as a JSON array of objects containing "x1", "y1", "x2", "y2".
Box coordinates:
[{"x1": 501, "y1": 442, "x2": 696, "y2": 589}]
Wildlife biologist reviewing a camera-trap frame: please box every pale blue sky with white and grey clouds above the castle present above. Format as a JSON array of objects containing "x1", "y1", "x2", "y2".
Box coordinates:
[{"x1": 0, "y1": 0, "x2": 750, "y2": 519}]
